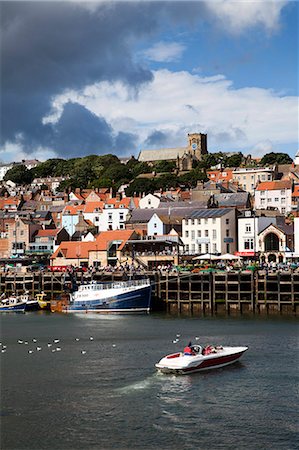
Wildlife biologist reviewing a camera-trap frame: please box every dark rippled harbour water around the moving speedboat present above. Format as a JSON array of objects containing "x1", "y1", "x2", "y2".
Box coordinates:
[{"x1": 0, "y1": 313, "x2": 299, "y2": 450}]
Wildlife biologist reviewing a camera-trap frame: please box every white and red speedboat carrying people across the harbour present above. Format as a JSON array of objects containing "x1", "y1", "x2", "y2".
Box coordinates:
[{"x1": 155, "y1": 345, "x2": 248, "y2": 375}]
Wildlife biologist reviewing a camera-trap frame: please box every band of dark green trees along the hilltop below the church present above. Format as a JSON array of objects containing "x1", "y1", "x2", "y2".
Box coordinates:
[{"x1": 4, "y1": 152, "x2": 292, "y2": 195}]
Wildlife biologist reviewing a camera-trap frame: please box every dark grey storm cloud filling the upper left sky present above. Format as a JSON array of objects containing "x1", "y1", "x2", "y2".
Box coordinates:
[{"x1": 0, "y1": 1, "x2": 207, "y2": 158}]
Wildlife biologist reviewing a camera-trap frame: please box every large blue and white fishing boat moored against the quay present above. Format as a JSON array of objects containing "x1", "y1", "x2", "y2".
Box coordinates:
[{"x1": 62, "y1": 279, "x2": 151, "y2": 313}]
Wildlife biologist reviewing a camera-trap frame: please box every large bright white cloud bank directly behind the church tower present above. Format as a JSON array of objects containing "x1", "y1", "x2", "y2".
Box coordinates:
[{"x1": 45, "y1": 70, "x2": 298, "y2": 154}]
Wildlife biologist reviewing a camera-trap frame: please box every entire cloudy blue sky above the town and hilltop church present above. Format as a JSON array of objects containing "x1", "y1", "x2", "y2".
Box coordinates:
[{"x1": 0, "y1": 0, "x2": 299, "y2": 163}]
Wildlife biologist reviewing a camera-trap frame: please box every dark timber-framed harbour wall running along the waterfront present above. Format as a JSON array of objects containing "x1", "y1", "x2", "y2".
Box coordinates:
[{"x1": 0, "y1": 271, "x2": 299, "y2": 316}]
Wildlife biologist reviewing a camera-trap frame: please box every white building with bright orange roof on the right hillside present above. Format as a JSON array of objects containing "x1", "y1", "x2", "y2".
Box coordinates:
[{"x1": 254, "y1": 180, "x2": 292, "y2": 214}]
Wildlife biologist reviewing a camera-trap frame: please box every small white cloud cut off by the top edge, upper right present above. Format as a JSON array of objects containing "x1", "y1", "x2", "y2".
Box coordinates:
[{"x1": 205, "y1": 0, "x2": 289, "y2": 33}]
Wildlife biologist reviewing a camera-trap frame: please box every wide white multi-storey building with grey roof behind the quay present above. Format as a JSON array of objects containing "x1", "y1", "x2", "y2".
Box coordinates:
[{"x1": 182, "y1": 208, "x2": 237, "y2": 254}]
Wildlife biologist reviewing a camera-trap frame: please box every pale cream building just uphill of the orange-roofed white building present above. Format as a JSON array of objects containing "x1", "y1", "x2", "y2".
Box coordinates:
[{"x1": 233, "y1": 166, "x2": 277, "y2": 195}]
